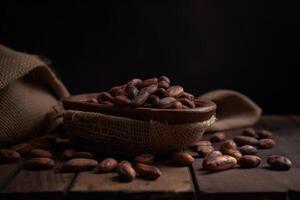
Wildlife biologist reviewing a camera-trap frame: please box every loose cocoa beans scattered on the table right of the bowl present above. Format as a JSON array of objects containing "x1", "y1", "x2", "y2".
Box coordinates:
[{"x1": 192, "y1": 128, "x2": 292, "y2": 171}]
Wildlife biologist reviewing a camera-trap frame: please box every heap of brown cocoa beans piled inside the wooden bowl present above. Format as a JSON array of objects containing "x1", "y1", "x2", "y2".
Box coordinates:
[{"x1": 95, "y1": 76, "x2": 196, "y2": 109}]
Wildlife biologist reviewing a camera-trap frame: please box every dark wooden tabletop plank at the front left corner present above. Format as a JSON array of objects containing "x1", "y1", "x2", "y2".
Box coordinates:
[{"x1": 0, "y1": 161, "x2": 75, "y2": 200}]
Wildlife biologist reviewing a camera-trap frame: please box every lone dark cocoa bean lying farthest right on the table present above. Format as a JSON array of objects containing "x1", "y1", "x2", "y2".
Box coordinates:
[{"x1": 267, "y1": 155, "x2": 293, "y2": 170}]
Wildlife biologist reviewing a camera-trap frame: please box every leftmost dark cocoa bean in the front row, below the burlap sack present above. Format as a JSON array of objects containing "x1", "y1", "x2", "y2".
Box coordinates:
[{"x1": 24, "y1": 158, "x2": 55, "y2": 170}]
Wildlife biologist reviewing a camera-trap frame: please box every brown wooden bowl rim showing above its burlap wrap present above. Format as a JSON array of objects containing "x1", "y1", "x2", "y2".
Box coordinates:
[{"x1": 63, "y1": 93, "x2": 217, "y2": 124}]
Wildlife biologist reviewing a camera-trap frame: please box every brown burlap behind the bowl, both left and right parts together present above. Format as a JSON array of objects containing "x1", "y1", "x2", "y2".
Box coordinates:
[{"x1": 0, "y1": 45, "x2": 262, "y2": 147}]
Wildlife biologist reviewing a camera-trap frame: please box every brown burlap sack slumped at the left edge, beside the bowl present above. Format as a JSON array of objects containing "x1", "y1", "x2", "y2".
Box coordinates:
[{"x1": 0, "y1": 45, "x2": 69, "y2": 147}]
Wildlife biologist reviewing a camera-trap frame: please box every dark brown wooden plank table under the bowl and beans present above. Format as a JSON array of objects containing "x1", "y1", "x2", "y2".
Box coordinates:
[{"x1": 0, "y1": 116, "x2": 300, "y2": 200}]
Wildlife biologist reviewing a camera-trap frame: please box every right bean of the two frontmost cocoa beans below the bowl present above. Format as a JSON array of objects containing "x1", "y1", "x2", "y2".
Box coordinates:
[{"x1": 135, "y1": 163, "x2": 162, "y2": 180}]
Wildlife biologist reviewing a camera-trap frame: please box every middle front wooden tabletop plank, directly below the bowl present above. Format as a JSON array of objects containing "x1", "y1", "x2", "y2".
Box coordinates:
[{"x1": 70, "y1": 164, "x2": 195, "y2": 200}]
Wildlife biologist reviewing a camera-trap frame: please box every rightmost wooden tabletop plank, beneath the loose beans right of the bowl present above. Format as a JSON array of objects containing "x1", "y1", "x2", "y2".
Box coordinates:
[{"x1": 193, "y1": 117, "x2": 300, "y2": 199}]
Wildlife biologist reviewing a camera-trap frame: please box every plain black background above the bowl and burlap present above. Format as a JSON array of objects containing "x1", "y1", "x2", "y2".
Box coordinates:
[{"x1": 0, "y1": 0, "x2": 300, "y2": 114}]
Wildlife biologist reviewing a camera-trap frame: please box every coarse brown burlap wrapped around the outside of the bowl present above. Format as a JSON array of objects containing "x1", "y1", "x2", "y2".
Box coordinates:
[{"x1": 64, "y1": 110, "x2": 215, "y2": 154}]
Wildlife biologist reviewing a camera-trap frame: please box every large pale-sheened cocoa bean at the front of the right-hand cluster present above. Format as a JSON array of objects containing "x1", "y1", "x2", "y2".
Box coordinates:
[{"x1": 206, "y1": 155, "x2": 237, "y2": 171}]
